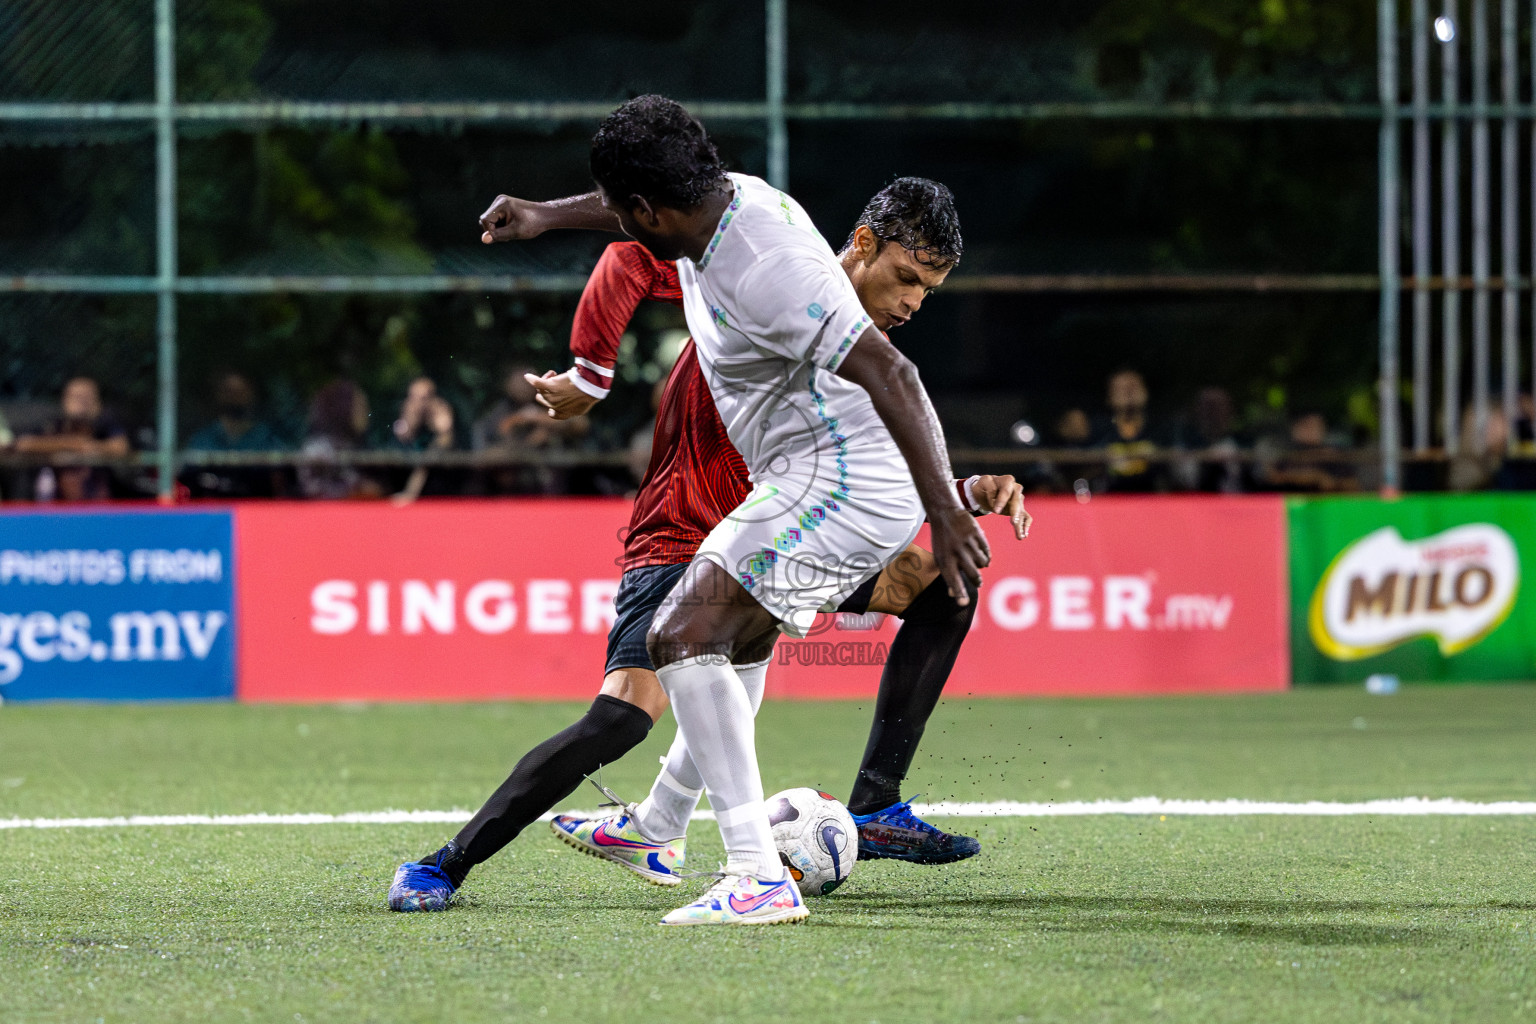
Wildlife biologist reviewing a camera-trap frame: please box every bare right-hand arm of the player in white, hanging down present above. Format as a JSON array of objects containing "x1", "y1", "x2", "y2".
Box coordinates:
[{"x1": 837, "y1": 327, "x2": 992, "y2": 605}]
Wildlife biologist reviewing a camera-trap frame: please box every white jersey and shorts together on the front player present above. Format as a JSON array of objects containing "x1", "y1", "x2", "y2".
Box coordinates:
[{"x1": 677, "y1": 175, "x2": 923, "y2": 636}]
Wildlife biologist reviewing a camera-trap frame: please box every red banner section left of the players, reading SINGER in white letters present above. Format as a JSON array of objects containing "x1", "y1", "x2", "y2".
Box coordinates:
[{"x1": 235, "y1": 499, "x2": 630, "y2": 700}]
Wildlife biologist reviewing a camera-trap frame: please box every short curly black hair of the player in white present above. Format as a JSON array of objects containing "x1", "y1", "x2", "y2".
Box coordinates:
[{"x1": 591, "y1": 95, "x2": 725, "y2": 210}]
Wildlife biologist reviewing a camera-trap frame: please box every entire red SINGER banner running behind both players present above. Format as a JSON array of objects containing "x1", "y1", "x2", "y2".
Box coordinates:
[{"x1": 237, "y1": 497, "x2": 1289, "y2": 700}]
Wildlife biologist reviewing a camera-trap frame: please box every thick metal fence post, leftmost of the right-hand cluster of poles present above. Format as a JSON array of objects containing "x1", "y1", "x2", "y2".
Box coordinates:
[{"x1": 1378, "y1": 0, "x2": 1402, "y2": 493}]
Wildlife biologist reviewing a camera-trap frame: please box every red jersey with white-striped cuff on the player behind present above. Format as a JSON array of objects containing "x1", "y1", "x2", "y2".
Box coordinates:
[{"x1": 571, "y1": 241, "x2": 750, "y2": 573}]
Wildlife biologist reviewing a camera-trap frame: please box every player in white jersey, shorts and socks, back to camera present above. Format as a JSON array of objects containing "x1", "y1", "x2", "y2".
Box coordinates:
[{"x1": 577, "y1": 97, "x2": 989, "y2": 924}]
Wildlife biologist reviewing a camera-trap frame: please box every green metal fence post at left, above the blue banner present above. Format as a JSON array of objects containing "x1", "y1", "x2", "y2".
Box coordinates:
[{"x1": 155, "y1": 0, "x2": 177, "y2": 502}]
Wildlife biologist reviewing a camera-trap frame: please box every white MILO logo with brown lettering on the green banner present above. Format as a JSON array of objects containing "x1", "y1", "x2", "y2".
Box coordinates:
[{"x1": 1307, "y1": 522, "x2": 1521, "y2": 662}]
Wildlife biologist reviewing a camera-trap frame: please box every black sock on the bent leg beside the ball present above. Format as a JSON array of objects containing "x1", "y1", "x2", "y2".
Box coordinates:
[{"x1": 848, "y1": 577, "x2": 977, "y2": 814}]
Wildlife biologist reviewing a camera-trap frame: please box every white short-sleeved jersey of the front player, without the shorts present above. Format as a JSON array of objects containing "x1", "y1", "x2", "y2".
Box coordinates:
[{"x1": 677, "y1": 173, "x2": 912, "y2": 490}]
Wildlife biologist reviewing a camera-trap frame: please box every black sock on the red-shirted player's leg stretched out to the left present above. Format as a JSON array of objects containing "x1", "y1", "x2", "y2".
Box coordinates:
[{"x1": 424, "y1": 694, "x2": 651, "y2": 886}]
